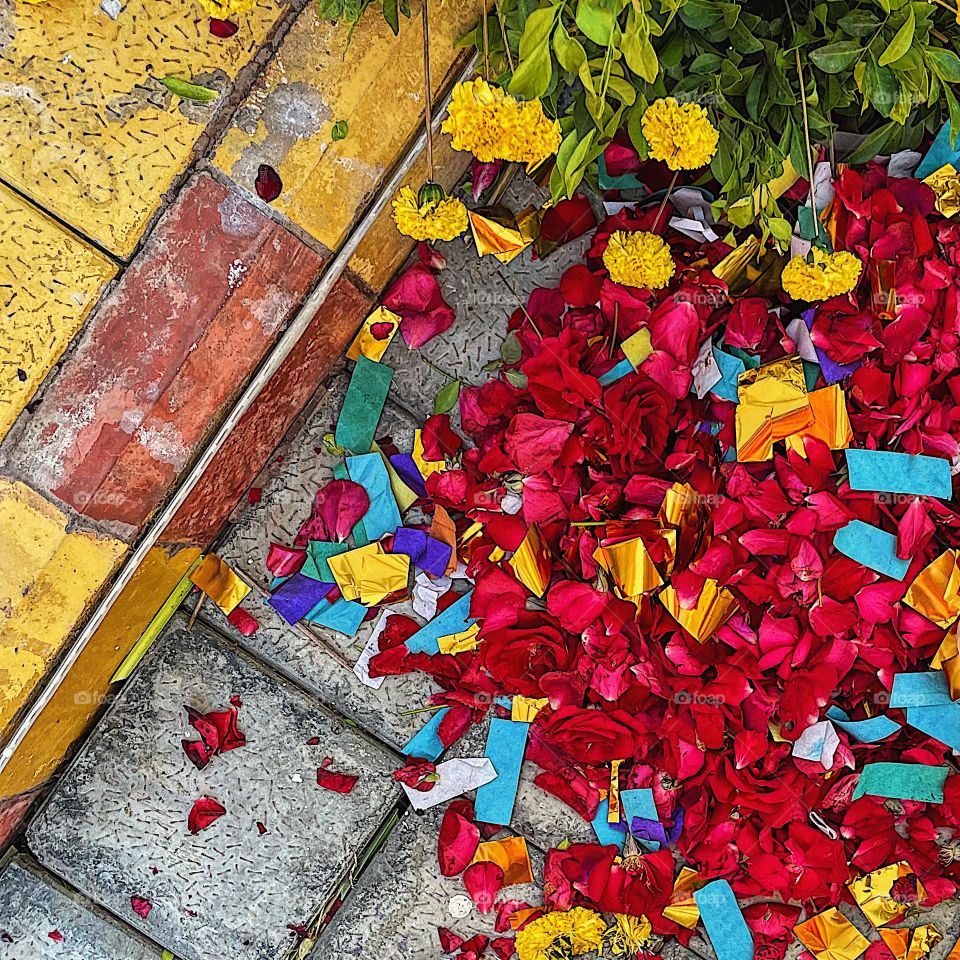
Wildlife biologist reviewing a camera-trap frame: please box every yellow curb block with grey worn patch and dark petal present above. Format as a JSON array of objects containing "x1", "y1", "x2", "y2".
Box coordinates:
[{"x1": 215, "y1": 0, "x2": 480, "y2": 250}]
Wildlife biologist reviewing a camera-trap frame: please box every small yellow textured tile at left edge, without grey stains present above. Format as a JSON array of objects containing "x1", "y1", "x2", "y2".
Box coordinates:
[{"x1": 0, "y1": 184, "x2": 116, "y2": 440}]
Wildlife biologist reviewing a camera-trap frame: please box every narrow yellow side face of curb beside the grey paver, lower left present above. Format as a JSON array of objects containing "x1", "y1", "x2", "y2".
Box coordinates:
[{"x1": 0, "y1": 546, "x2": 200, "y2": 799}]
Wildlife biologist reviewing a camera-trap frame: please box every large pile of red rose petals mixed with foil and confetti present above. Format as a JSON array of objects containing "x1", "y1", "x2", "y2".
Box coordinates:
[{"x1": 370, "y1": 165, "x2": 960, "y2": 957}]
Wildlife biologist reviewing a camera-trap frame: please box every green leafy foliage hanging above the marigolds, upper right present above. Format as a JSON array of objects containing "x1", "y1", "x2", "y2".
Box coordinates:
[{"x1": 462, "y1": 0, "x2": 960, "y2": 242}]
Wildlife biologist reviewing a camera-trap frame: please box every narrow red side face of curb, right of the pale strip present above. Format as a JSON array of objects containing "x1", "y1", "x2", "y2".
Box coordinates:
[{"x1": 163, "y1": 278, "x2": 373, "y2": 545}]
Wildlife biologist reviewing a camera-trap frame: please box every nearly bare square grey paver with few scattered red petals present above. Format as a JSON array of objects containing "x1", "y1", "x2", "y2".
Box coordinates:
[{"x1": 27, "y1": 617, "x2": 400, "y2": 960}]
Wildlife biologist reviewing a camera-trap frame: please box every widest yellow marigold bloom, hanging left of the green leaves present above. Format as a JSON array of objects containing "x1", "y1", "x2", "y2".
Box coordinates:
[{"x1": 442, "y1": 77, "x2": 560, "y2": 164}]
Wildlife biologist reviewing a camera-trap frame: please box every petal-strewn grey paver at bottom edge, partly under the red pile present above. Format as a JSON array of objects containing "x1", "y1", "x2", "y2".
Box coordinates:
[{"x1": 310, "y1": 808, "x2": 543, "y2": 960}]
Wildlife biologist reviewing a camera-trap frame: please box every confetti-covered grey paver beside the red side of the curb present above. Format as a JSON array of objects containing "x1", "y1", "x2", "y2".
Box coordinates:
[{"x1": 210, "y1": 362, "x2": 437, "y2": 748}]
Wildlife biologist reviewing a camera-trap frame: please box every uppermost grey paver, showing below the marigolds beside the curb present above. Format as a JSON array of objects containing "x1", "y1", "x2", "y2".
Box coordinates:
[{"x1": 384, "y1": 175, "x2": 591, "y2": 419}]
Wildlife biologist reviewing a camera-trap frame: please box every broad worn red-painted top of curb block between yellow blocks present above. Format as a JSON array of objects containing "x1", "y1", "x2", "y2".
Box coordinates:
[{"x1": 13, "y1": 175, "x2": 322, "y2": 536}]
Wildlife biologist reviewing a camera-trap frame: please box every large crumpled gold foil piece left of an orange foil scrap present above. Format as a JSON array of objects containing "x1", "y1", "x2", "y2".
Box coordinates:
[{"x1": 736, "y1": 356, "x2": 813, "y2": 463}]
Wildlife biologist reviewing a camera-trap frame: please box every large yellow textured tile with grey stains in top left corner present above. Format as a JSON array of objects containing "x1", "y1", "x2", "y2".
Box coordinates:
[{"x1": 0, "y1": 0, "x2": 284, "y2": 256}]
